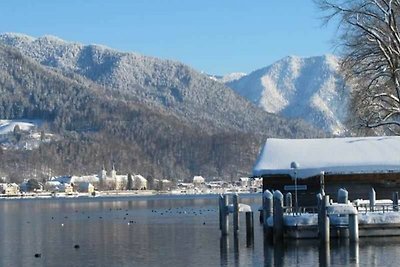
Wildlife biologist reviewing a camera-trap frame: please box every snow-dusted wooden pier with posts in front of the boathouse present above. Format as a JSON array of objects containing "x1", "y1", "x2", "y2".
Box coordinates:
[{"x1": 260, "y1": 188, "x2": 400, "y2": 243}]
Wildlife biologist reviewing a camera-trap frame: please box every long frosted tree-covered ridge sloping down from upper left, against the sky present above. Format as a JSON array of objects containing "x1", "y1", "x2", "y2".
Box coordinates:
[{"x1": 0, "y1": 33, "x2": 322, "y2": 136}]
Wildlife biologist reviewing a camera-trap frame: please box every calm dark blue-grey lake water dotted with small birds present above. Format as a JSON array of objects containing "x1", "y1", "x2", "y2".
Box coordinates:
[{"x1": 0, "y1": 195, "x2": 400, "y2": 267}]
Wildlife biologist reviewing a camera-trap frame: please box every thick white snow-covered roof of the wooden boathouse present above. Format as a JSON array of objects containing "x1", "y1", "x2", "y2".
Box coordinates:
[{"x1": 253, "y1": 136, "x2": 400, "y2": 178}]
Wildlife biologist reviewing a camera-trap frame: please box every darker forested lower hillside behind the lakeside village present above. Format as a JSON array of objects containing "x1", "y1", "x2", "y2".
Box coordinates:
[{"x1": 0, "y1": 42, "x2": 318, "y2": 183}]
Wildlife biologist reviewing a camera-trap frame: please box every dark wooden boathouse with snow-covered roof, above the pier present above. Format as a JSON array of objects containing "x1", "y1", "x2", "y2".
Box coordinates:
[{"x1": 253, "y1": 136, "x2": 400, "y2": 205}]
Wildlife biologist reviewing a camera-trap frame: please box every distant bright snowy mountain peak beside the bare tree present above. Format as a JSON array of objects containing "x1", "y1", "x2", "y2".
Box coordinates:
[{"x1": 226, "y1": 55, "x2": 350, "y2": 135}]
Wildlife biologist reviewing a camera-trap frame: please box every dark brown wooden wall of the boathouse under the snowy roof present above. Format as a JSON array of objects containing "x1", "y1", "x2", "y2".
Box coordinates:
[{"x1": 263, "y1": 172, "x2": 400, "y2": 206}]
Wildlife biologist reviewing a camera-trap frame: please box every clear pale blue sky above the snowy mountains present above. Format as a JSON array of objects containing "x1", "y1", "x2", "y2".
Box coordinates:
[{"x1": 0, "y1": 0, "x2": 336, "y2": 75}]
